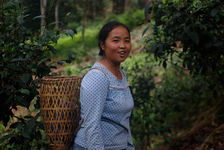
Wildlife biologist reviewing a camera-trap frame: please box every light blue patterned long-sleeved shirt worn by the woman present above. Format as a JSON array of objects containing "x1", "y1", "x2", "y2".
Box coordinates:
[{"x1": 75, "y1": 63, "x2": 134, "y2": 150}]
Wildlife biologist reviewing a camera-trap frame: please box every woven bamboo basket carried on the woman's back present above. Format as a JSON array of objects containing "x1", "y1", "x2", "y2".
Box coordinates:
[{"x1": 40, "y1": 76, "x2": 82, "y2": 150}]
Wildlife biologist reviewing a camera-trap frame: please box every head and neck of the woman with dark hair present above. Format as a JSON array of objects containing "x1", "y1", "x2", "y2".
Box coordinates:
[{"x1": 98, "y1": 22, "x2": 131, "y2": 79}]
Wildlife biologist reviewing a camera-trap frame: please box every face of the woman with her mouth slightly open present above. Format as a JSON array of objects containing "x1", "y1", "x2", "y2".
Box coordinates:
[{"x1": 101, "y1": 26, "x2": 131, "y2": 63}]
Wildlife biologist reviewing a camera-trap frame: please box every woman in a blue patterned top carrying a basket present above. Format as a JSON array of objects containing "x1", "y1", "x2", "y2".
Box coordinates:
[{"x1": 73, "y1": 22, "x2": 134, "y2": 150}]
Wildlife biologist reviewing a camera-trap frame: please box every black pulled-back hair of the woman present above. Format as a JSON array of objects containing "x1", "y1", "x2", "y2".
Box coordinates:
[{"x1": 98, "y1": 21, "x2": 130, "y2": 56}]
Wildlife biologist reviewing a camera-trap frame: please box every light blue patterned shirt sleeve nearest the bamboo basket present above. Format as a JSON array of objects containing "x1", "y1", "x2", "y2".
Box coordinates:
[{"x1": 80, "y1": 70, "x2": 109, "y2": 150}]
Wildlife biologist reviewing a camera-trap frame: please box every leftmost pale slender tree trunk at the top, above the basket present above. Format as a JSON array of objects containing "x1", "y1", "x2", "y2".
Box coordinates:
[{"x1": 40, "y1": 0, "x2": 47, "y2": 35}]
